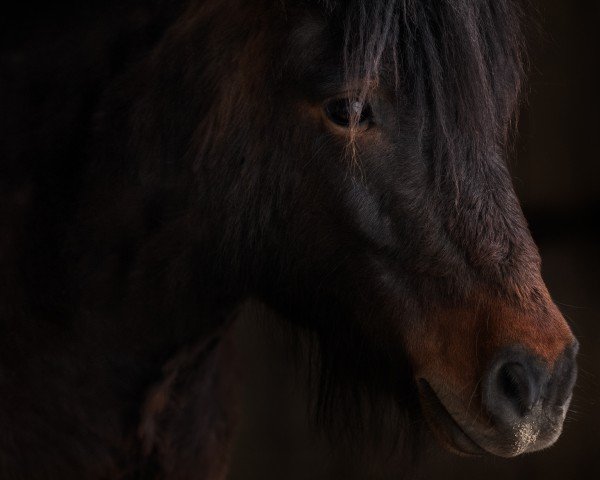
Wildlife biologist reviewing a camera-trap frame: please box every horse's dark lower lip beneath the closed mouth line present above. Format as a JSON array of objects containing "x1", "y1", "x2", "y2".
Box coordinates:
[{"x1": 418, "y1": 379, "x2": 486, "y2": 456}]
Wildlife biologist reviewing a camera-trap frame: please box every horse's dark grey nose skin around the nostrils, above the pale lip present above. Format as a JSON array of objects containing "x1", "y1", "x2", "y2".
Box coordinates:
[{"x1": 482, "y1": 342, "x2": 579, "y2": 427}]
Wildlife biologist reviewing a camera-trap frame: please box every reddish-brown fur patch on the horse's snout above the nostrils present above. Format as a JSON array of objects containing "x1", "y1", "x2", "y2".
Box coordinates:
[{"x1": 415, "y1": 297, "x2": 576, "y2": 391}]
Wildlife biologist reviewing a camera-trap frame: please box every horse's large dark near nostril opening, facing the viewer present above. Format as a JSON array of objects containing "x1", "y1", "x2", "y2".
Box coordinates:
[{"x1": 497, "y1": 362, "x2": 539, "y2": 415}]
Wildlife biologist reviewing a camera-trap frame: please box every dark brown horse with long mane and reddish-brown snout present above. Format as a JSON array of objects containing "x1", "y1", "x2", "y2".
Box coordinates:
[{"x1": 0, "y1": 0, "x2": 578, "y2": 480}]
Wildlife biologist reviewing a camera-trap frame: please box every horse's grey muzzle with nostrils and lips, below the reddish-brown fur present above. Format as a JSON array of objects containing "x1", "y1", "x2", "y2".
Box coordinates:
[{"x1": 419, "y1": 341, "x2": 579, "y2": 457}]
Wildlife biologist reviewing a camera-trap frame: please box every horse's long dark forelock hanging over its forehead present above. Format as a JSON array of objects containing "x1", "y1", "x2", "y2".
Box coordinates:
[{"x1": 300, "y1": 0, "x2": 524, "y2": 171}]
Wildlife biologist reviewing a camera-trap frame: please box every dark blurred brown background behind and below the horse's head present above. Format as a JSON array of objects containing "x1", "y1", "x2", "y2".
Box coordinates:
[{"x1": 229, "y1": 0, "x2": 600, "y2": 480}]
